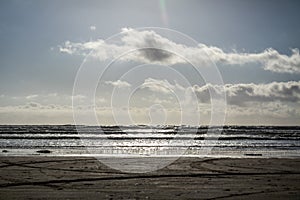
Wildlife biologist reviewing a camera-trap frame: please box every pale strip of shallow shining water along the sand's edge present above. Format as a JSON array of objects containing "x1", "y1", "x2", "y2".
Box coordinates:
[{"x1": 0, "y1": 148, "x2": 300, "y2": 159}]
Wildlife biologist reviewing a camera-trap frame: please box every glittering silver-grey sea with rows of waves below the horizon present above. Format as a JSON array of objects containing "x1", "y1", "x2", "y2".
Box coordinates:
[{"x1": 0, "y1": 125, "x2": 300, "y2": 158}]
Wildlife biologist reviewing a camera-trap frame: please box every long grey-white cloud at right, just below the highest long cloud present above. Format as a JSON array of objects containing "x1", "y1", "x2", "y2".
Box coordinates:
[{"x1": 141, "y1": 78, "x2": 300, "y2": 106}]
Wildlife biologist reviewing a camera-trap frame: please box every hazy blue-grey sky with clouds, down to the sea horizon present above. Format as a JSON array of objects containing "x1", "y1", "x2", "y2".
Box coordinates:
[{"x1": 0, "y1": 0, "x2": 300, "y2": 125}]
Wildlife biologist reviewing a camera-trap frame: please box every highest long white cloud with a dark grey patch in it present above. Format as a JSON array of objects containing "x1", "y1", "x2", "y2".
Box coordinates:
[{"x1": 59, "y1": 29, "x2": 300, "y2": 73}]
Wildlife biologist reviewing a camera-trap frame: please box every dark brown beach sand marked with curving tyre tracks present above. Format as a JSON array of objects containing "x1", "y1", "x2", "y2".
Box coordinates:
[{"x1": 0, "y1": 156, "x2": 300, "y2": 199}]
